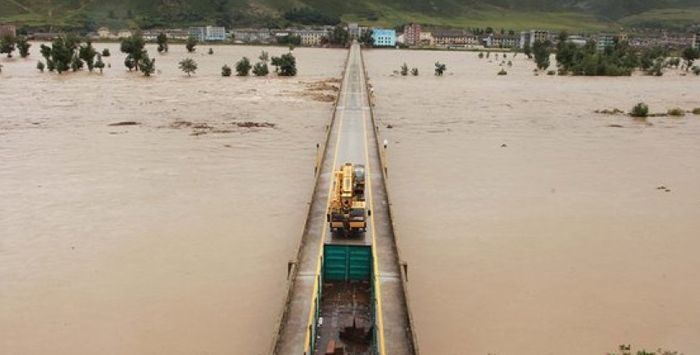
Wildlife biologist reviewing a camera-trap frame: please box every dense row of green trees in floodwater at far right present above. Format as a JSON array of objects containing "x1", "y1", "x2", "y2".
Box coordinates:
[{"x1": 524, "y1": 32, "x2": 700, "y2": 76}]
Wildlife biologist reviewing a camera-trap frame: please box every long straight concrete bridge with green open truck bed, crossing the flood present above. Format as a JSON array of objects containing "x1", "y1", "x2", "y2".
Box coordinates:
[{"x1": 271, "y1": 43, "x2": 418, "y2": 355}]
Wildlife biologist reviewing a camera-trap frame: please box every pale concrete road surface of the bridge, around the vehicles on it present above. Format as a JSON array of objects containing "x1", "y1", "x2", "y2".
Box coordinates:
[{"x1": 273, "y1": 44, "x2": 416, "y2": 355}]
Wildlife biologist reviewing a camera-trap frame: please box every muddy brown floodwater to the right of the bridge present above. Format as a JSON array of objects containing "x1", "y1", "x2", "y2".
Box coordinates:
[{"x1": 365, "y1": 50, "x2": 700, "y2": 355}]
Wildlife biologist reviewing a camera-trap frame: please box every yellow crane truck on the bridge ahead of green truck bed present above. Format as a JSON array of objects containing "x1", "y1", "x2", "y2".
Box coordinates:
[{"x1": 326, "y1": 163, "x2": 367, "y2": 234}]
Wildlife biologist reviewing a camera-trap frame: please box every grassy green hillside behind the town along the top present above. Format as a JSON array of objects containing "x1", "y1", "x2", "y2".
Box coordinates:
[{"x1": 0, "y1": 0, "x2": 700, "y2": 31}]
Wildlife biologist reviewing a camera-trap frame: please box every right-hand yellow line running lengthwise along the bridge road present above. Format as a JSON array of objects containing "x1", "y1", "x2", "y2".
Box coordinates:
[{"x1": 360, "y1": 56, "x2": 386, "y2": 355}]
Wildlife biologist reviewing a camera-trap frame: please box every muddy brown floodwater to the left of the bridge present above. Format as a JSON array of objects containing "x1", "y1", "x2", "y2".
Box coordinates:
[{"x1": 0, "y1": 43, "x2": 346, "y2": 355}]
